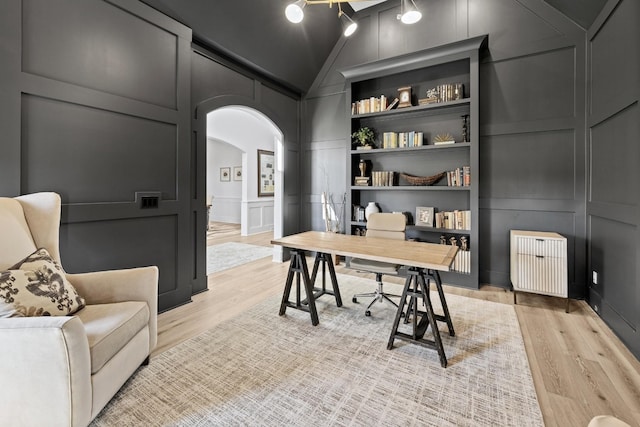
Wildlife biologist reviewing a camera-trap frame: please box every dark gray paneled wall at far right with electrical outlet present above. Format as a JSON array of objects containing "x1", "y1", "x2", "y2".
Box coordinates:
[{"x1": 587, "y1": 0, "x2": 640, "y2": 357}]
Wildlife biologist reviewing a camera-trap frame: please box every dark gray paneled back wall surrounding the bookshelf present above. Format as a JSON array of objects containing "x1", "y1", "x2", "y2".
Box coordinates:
[{"x1": 302, "y1": 0, "x2": 586, "y2": 297}]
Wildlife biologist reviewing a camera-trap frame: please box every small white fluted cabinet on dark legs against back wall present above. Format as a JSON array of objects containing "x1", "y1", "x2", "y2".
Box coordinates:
[{"x1": 510, "y1": 230, "x2": 569, "y2": 312}]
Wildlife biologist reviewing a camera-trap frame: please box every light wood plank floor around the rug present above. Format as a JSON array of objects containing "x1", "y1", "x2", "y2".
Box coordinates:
[{"x1": 153, "y1": 227, "x2": 640, "y2": 427}]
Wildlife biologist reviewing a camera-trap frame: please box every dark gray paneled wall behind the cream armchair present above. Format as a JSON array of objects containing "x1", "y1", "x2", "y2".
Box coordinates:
[{"x1": 0, "y1": 0, "x2": 193, "y2": 310}]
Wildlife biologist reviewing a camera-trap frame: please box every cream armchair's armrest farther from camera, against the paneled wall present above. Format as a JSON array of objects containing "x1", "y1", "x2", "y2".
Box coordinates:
[{"x1": 66, "y1": 266, "x2": 158, "y2": 351}]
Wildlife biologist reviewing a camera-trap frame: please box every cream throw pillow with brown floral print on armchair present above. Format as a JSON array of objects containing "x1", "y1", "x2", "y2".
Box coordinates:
[{"x1": 0, "y1": 248, "x2": 85, "y2": 318}]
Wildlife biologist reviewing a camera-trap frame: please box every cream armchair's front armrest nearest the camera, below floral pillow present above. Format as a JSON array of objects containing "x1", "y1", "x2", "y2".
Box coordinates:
[{"x1": 0, "y1": 317, "x2": 92, "y2": 426}]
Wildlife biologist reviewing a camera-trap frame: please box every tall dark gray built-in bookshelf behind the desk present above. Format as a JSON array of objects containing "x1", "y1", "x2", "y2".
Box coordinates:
[{"x1": 341, "y1": 36, "x2": 487, "y2": 288}]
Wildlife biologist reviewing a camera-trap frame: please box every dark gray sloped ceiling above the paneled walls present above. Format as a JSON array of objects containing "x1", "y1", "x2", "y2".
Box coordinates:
[{"x1": 142, "y1": 0, "x2": 607, "y2": 94}]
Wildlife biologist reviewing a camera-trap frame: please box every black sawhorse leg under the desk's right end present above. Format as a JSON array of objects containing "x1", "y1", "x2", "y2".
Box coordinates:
[{"x1": 387, "y1": 267, "x2": 455, "y2": 368}]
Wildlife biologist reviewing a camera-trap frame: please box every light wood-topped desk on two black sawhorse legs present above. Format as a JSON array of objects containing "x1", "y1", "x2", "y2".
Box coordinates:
[{"x1": 271, "y1": 231, "x2": 458, "y2": 367}]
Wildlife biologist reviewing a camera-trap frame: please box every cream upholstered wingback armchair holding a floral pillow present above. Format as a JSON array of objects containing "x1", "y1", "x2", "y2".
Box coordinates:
[{"x1": 0, "y1": 193, "x2": 158, "y2": 426}]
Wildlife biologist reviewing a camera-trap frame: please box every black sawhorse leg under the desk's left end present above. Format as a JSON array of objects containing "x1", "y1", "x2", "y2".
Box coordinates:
[{"x1": 279, "y1": 249, "x2": 342, "y2": 326}]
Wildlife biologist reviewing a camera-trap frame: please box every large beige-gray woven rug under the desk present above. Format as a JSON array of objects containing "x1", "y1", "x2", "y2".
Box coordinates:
[{"x1": 93, "y1": 275, "x2": 543, "y2": 426}]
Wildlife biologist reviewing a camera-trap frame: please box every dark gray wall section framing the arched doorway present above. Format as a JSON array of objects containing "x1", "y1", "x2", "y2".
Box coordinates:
[{"x1": 191, "y1": 48, "x2": 300, "y2": 292}]
